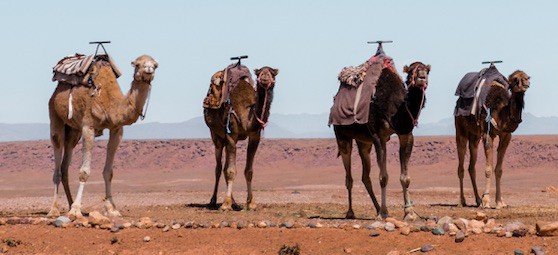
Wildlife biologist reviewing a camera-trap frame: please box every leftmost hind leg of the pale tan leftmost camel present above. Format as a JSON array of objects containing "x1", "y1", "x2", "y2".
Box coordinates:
[{"x1": 47, "y1": 112, "x2": 65, "y2": 217}]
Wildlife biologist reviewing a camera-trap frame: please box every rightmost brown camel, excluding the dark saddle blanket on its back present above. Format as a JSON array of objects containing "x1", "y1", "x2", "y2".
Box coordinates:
[{"x1": 455, "y1": 70, "x2": 530, "y2": 209}]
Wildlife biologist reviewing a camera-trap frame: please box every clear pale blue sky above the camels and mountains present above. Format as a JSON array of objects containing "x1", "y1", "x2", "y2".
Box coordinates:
[{"x1": 0, "y1": 0, "x2": 558, "y2": 125}]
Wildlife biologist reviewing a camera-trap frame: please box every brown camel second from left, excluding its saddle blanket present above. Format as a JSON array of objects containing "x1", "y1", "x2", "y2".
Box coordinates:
[{"x1": 204, "y1": 66, "x2": 279, "y2": 210}]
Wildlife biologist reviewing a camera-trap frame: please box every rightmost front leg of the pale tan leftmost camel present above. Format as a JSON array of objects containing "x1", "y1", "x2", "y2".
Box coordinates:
[{"x1": 103, "y1": 127, "x2": 123, "y2": 217}]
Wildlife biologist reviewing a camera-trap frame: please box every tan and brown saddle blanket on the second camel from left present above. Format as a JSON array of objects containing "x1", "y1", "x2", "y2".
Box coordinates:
[{"x1": 203, "y1": 64, "x2": 256, "y2": 109}]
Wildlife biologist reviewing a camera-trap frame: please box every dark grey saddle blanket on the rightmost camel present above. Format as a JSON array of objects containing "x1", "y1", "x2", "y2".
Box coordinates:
[{"x1": 454, "y1": 65, "x2": 509, "y2": 116}]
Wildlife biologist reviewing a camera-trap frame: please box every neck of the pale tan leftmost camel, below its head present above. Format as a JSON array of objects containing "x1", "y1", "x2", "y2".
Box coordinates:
[{"x1": 124, "y1": 80, "x2": 151, "y2": 125}]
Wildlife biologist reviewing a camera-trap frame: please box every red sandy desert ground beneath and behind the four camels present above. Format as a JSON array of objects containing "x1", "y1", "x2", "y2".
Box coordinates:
[{"x1": 0, "y1": 136, "x2": 558, "y2": 254}]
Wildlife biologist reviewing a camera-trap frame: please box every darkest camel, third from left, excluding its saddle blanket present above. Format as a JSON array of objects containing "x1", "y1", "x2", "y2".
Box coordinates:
[{"x1": 334, "y1": 62, "x2": 430, "y2": 221}]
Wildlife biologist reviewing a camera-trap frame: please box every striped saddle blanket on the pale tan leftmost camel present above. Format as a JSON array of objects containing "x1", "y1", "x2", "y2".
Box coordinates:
[{"x1": 52, "y1": 53, "x2": 122, "y2": 86}]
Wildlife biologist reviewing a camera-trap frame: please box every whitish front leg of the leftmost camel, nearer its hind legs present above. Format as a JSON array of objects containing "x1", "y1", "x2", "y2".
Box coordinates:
[{"x1": 68, "y1": 126, "x2": 95, "y2": 217}]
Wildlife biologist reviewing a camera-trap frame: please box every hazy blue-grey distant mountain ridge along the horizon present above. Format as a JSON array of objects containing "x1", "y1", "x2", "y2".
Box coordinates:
[{"x1": 0, "y1": 113, "x2": 558, "y2": 142}]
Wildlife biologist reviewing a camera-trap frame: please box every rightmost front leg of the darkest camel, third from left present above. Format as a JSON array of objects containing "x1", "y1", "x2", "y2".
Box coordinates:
[{"x1": 398, "y1": 133, "x2": 418, "y2": 221}]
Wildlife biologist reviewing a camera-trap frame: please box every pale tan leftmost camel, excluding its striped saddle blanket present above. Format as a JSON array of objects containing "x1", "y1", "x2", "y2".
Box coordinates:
[{"x1": 48, "y1": 55, "x2": 158, "y2": 217}]
